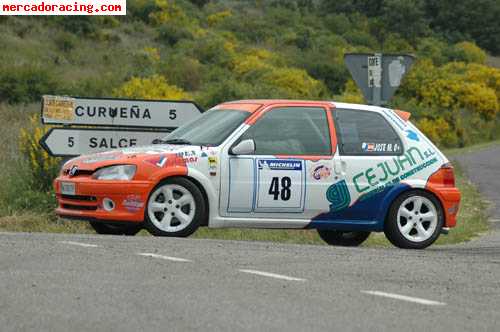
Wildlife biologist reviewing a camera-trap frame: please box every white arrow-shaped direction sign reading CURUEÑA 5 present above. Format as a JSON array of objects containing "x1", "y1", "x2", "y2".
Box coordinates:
[{"x1": 42, "y1": 96, "x2": 202, "y2": 128}]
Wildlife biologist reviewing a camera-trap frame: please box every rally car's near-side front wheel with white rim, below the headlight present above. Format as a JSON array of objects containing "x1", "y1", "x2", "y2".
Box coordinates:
[{"x1": 144, "y1": 177, "x2": 206, "y2": 237}]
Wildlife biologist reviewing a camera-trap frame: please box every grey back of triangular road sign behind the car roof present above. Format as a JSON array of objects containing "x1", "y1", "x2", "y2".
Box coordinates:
[{"x1": 344, "y1": 53, "x2": 415, "y2": 105}]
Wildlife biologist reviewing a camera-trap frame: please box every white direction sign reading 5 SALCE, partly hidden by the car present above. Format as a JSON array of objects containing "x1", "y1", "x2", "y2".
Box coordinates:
[{"x1": 40, "y1": 128, "x2": 168, "y2": 157}]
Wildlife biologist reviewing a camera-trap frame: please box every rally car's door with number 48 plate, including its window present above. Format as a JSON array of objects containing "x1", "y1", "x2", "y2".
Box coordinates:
[{"x1": 221, "y1": 107, "x2": 335, "y2": 219}]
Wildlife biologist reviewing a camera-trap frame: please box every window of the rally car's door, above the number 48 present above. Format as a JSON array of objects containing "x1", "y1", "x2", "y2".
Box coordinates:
[{"x1": 240, "y1": 107, "x2": 332, "y2": 156}]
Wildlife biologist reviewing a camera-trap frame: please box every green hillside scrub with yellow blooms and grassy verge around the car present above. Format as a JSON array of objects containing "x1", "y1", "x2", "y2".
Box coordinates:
[{"x1": 0, "y1": 0, "x2": 500, "y2": 244}]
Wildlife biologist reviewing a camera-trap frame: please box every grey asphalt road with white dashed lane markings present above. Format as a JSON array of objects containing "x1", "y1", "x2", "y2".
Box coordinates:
[{"x1": 0, "y1": 146, "x2": 500, "y2": 331}]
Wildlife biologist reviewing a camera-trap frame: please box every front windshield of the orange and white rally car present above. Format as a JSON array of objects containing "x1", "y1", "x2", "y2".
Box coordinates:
[{"x1": 160, "y1": 109, "x2": 250, "y2": 146}]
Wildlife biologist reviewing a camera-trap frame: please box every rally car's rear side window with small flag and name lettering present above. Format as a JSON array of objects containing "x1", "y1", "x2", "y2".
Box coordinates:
[{"x1": 334, "y1": 109, "x2": 403, "y2": 156}]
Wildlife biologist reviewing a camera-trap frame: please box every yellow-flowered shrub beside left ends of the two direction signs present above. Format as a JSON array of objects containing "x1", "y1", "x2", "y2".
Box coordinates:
[{"x1": 19, "y1": 114, "x2": 61, "y2": 191}]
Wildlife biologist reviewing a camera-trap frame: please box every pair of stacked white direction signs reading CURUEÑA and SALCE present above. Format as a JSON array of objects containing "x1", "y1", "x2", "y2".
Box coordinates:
[{"x1": 40, "y1": 96, "x2": 202, "y2": 157}]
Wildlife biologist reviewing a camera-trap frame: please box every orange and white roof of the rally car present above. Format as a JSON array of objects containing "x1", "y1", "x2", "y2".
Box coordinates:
[{"x1": 214, "y1": 99, "x2": 386, "y2": 113}]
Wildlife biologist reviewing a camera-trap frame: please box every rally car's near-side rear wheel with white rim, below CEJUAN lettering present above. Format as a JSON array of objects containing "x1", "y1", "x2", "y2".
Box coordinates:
[{"x1": 384, "y1": 190, "x2": 444, "y2": 249}]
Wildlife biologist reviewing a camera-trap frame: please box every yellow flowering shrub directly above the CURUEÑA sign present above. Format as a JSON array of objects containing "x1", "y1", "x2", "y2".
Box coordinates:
[{"x1": 113, "y1": 75, "x2": 191, "y2": 100}]
